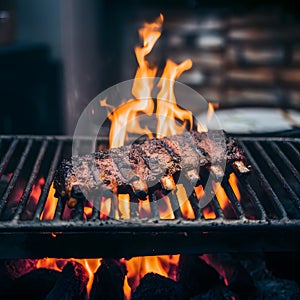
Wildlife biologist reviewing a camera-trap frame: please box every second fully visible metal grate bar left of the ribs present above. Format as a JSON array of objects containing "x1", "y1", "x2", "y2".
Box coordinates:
[{"x1": 13, "y1": 141, "x2": 48, "y2": 221}]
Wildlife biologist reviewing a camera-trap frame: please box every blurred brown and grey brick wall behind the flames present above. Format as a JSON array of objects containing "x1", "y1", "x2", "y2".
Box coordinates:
[{"x1": 142, "y1": 8, "x2": 300, "y2": 108}]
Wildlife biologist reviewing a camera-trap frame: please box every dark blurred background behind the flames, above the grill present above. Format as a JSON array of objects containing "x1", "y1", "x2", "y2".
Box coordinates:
[{"x1": 0, "y1": 0, "x2": 300, "y2": 135}]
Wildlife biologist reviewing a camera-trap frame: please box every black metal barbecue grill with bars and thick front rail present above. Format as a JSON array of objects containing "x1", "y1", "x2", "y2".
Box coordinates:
[{"x1": 0, "y1": 136, "x2": 300, "y2": 258}]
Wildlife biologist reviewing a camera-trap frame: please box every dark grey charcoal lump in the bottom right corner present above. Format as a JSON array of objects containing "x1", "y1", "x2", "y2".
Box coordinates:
[{"x1": 248, "y1": 278, "x2": 300, "y2": 300}]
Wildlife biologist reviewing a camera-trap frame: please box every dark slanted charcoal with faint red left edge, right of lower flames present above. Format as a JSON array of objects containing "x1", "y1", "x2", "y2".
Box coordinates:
[{"x1": 201, "y1": 254, "x2": 255, "y2": 299}]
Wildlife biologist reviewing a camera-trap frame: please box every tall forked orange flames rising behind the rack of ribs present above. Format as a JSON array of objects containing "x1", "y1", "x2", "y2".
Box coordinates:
[{"x1": 100, "y1": 14, "x2": 197, "y2": 148}]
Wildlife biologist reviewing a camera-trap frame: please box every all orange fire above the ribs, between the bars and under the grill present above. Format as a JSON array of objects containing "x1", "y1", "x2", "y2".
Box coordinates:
[{"x1": 11, "y1": 15, "x2": 240, "y2": 299}]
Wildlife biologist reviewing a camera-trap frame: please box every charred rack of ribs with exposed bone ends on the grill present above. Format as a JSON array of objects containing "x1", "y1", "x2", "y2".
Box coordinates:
[{"x1": 54, "y1": 131, "x2": 249, "y2": 203}]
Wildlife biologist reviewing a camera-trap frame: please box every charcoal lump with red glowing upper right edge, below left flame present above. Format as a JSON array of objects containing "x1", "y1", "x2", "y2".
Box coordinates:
[{"x1": 43, "y1": 261, "x2": 88, "y2": 300}]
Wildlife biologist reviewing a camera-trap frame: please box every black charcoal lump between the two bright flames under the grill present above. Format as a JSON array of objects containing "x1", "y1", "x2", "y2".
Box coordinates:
[{"x1": 90, "y1": 259, "x2": 127, "y2": 300}]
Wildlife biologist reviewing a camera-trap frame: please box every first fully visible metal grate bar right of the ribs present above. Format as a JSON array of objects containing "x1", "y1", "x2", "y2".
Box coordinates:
[{"x1": 239, "y1": 141, "x2": 287, "y2": 219}]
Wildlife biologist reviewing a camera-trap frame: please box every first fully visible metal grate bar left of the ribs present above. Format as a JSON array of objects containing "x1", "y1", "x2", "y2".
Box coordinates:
[{"x1": 33, "y1": 141, "x2": 63, "y2": 221}]
